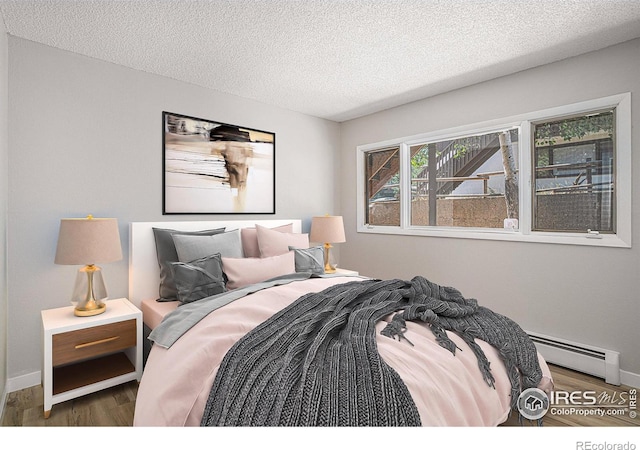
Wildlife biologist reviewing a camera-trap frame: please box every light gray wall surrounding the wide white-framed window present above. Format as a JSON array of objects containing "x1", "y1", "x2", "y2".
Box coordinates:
[{"x1": 340, "y1": 40, "x2": 640, "y2": 382}]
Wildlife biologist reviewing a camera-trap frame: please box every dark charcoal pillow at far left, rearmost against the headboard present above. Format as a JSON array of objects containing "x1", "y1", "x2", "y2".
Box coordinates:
[{"x1": 153, "y1": 228, "x2": 224, "y2": 302}]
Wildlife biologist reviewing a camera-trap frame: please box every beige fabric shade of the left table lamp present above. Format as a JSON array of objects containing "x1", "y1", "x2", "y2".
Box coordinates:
[{"x1": 55, "y1": 216, "x2": 122, "y2": 265}]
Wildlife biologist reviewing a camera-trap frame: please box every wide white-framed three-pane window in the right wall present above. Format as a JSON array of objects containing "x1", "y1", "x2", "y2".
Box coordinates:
[{"x1": 358, "y1": 94, "x2": 631, "y2": 247}]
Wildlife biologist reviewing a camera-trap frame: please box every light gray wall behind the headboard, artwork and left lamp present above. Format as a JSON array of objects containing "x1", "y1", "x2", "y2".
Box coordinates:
[{"x1": 5, "y1": 37, "x2": 339, "y2": 385}]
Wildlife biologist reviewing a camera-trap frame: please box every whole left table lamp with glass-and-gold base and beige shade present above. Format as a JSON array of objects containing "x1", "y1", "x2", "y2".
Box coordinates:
[{"x1": 55, "y1": 215, "x2": 122, "y2": 316}]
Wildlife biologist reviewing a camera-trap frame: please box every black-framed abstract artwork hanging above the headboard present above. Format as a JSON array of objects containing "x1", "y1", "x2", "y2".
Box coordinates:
[{"x1": 162, "y1": 111, "x2": 276, "y2": 214}]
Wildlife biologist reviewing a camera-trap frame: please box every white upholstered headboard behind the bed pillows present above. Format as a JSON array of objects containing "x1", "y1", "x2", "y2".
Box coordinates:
[{"x1": 129, "y1": 219, "x2": 302, "y2": 308}]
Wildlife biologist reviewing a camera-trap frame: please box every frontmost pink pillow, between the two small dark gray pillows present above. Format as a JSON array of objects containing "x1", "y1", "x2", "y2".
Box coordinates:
[{"x1": 222, "y1": 251, "x2": 296, "y2": 289}]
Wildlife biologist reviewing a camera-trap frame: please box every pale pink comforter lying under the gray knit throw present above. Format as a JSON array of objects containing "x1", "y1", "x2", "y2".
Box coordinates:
[{"x1": 134, "y1": 277, "x2": 551, "y2": 426}]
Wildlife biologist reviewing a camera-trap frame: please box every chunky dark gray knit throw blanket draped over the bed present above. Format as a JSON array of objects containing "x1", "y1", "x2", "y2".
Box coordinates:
[{"x1": 201, "y1": 277, "x2": 542, "y2": 426}]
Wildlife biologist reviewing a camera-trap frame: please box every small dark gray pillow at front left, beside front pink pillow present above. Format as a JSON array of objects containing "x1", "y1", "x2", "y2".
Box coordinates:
[{"x1": 171, "y1": 253, "x2": 227, "y2": 305}]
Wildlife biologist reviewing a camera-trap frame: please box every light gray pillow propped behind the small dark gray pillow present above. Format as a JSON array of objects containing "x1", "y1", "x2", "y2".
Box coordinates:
[{"x1": 173, "y1": 230, "x2": 244, "y2": 262}]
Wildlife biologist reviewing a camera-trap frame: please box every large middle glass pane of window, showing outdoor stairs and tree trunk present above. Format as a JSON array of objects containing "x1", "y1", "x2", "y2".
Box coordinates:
[{"x1": 410, "y1": 129, "x2": 518, "y2": 228}]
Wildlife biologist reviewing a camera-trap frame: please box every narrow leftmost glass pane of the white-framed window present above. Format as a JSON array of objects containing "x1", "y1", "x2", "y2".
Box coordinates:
[{"x1": 365, "y1": 147, "x2": 400, "y2": 226}]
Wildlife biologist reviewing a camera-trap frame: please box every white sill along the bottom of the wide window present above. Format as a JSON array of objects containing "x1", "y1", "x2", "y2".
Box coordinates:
[{"x1": 358, "y1": 225, "x2": 631, "y2": 248}]
